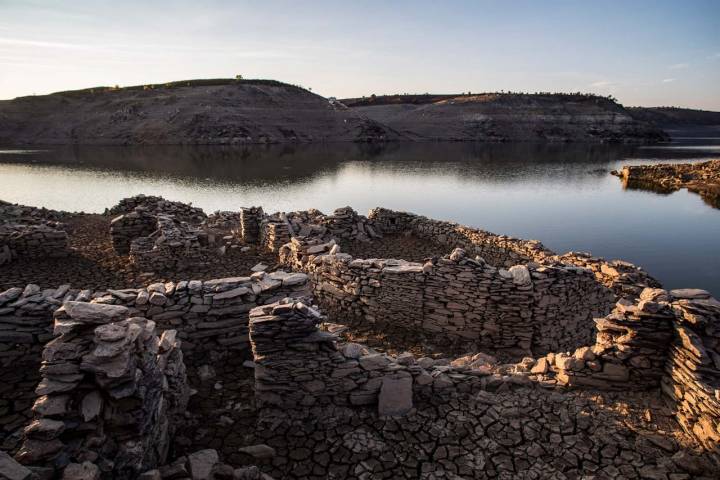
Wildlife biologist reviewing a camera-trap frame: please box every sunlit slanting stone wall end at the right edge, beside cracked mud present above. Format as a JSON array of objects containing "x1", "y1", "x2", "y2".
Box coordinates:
[{"x1": 662, "y1": 289, "x2": 720, "y2": 456}]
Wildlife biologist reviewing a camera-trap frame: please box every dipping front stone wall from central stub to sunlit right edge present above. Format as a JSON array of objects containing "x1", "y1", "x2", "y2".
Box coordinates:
[{"x1": 250, "y1": 289, "x2": 720, "y2": 459}]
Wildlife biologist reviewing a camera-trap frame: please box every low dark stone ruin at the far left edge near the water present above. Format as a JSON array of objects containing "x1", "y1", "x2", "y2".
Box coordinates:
[{"x1": 0, "y1": 201, "x2": 69, "y2": 265}]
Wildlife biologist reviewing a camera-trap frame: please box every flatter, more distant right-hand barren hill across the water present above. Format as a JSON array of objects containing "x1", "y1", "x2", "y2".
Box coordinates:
[{"x1": 342, "y1": 93, "x2": 666, "y2": 143}]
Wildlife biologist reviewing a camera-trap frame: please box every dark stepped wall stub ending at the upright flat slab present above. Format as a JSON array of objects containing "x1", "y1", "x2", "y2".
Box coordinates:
[{"x1": 250, "y1": 299, "x2": 412, "y2": 416}]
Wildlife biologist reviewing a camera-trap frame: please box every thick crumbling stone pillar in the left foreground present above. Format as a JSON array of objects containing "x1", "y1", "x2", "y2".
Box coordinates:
[{"x1": 16, "y1": 301, "x2": 189, "y2": 478}]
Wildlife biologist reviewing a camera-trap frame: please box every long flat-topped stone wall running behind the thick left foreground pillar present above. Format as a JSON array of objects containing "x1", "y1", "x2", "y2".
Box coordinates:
[{"x1": 0, "y1": 272, "x2": 308, "y2": 456}]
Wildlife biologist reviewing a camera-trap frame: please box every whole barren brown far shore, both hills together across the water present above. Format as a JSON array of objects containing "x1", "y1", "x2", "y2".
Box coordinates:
[{"x1": 0, "y1": 79, "x2": 666, "y2": 145}]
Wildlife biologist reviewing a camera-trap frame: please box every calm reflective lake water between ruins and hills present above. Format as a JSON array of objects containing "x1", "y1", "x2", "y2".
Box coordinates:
[{"x1": 0, "y1": 137, "x2": 720, "y2": 297}]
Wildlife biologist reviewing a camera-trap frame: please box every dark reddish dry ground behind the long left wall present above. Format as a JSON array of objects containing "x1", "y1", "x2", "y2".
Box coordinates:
[{"x1": 0, "y1": 214, "x2": 277, "y2": 290}]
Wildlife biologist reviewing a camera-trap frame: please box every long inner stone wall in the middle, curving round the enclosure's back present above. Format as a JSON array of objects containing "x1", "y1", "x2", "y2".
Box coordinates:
[{"x1": 280, "y1": 238, "x2": 613, "y2": 352}]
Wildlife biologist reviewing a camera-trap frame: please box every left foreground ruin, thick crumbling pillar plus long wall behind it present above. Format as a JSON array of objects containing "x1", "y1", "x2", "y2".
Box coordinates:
[{"x1": 0, "y1": 271, "x2": 308, "y2": 478}]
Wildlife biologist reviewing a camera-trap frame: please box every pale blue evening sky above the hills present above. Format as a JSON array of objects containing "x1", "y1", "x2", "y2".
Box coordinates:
[{"x1": 0, "y1": 0, "x2": 720, "y2": 111}]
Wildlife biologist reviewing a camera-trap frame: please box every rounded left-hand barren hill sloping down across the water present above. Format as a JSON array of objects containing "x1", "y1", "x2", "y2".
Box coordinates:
[{"x1": 0, "y1": 79, "x2": 398, "y2": 145}]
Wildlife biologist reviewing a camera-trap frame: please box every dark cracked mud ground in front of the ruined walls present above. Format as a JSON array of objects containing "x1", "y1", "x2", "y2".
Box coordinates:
[{"x1": 174, "y1": 352, "x2": 717, "y2": 480}]
